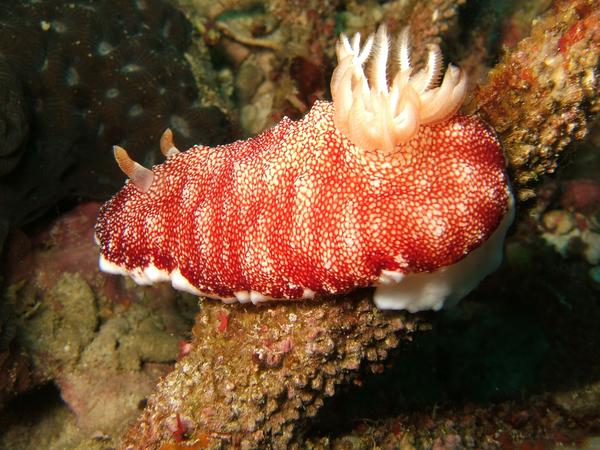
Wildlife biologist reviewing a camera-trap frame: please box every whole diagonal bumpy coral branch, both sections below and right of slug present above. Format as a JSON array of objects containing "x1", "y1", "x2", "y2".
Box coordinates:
[{"x1": 122, "y1": 1, "x2": 598, "y2": 449}]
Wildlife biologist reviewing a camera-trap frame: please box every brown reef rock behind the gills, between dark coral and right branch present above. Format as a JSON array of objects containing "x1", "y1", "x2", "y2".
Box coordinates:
[{"x1": 175, "y1": 0, "x2": 464, "y2": 136}]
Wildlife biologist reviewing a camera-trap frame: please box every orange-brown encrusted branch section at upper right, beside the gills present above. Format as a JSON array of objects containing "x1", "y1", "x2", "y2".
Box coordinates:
[{"x1": 471, "y1": 0, "x2": 600, "y2": 200}]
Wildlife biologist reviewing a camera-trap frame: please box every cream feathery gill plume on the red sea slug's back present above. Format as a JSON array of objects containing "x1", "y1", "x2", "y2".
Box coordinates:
[{"x1": 331, "y1": 26, "x2": 467, "y2": 152}]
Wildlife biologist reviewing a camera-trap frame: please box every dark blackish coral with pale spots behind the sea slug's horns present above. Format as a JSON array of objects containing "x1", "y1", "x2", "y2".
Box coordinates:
[{"x1": 0, "y1": 0, "x2": 230, "y2": 226}]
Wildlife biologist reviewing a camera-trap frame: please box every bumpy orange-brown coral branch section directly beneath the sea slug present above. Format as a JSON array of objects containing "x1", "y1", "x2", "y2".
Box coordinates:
[{"x1": 122, "y1": 296, "x2": 418, "y2": 449}]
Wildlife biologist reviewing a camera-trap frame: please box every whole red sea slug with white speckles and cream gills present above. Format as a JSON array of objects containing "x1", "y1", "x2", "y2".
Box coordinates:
[{"x1": 95, "y1": 27, "x2": 514, "y2": 312}]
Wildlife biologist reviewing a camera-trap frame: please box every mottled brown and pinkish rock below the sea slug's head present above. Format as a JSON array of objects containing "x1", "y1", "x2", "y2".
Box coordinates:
[{"x1": 0, "y1": 203, "x2": 196, "y2": 448}]
